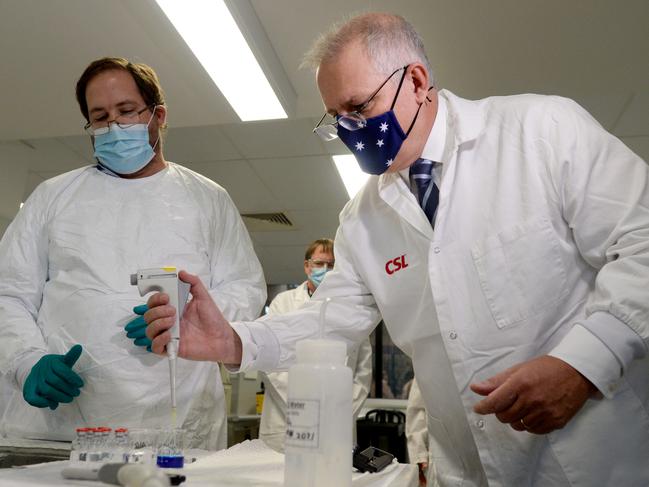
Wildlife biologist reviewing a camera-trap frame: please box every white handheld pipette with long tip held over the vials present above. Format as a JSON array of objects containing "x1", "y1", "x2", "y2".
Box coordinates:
[{"x1": 131, "y1": 267, "x2": 190, "y2": 427}]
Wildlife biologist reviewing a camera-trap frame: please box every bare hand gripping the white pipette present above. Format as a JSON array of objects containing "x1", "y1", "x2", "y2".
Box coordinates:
[{"x1": 144, "y1": 271, "x2": 241, "y2": 365}]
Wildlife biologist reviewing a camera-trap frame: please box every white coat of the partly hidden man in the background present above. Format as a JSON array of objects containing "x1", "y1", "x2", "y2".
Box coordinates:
[{"x1": 259, "y1": 282, "x2": 372, "y2": 452}]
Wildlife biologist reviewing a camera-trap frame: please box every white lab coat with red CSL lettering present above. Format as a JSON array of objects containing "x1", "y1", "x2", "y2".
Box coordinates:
[{"x1": 236, "y1": 91, "x2": 649, "y2": 487}]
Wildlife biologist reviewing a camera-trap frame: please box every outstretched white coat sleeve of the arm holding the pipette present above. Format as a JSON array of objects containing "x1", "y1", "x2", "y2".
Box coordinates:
[{"x1": 232, "y1": 219, "x2": 380, "y2": 371}]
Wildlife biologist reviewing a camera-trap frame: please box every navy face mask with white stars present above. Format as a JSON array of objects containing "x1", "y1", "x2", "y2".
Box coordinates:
[{"x1": 336, "y1": 66, "x2": 421, "y2": 175}]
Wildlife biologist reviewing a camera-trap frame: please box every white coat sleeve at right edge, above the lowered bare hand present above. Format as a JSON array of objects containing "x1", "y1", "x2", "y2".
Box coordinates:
[{"x1": 545, "y1": 97, "x2": 649, "y2": 397}]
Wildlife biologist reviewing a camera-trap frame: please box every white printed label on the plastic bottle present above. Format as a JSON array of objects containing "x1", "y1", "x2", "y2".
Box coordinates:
[{"x1": 286, "y1": 399, "x2": 320, "y2": 448}]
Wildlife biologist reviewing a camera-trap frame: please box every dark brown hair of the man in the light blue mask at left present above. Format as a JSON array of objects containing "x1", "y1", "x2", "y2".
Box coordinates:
[{"x1": 76, "y1": 57, "x2": 165, "y2": 121}]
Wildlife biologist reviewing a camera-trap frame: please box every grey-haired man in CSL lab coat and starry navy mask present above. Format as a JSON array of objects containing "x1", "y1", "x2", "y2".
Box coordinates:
[{"x1": 145, "y1": 14, "x2": 649, "y2": 487}]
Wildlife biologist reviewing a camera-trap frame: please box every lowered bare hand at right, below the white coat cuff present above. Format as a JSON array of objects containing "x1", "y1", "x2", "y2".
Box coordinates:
[{"x1": 471, "y1": 355, "x2": 597, "y2": 435}]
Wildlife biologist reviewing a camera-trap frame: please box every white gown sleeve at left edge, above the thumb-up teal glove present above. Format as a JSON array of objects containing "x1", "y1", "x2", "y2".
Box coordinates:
[{"x1": 0, "y1": 185, "x2": 49, "y2": 387}]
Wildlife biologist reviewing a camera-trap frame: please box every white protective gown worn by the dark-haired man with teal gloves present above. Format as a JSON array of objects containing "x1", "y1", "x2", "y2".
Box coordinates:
[{"x1": 0, "y1": 163, "x2": 266, "y2": 449}]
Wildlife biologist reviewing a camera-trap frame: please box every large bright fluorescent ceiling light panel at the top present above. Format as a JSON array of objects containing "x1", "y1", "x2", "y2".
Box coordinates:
[{"x1": 156, "y1": 0, "x2": 287, "y2": 122}]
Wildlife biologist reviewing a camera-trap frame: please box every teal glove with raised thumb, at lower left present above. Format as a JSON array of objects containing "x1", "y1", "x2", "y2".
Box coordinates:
[{"x1": 23, "y1": 344, "x2": 83, "y2": 410}]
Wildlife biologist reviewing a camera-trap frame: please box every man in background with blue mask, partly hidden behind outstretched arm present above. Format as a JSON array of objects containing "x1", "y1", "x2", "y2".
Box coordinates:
[{"x1": 259, "y1": 238, "x2": 372, "y2": 452}]
